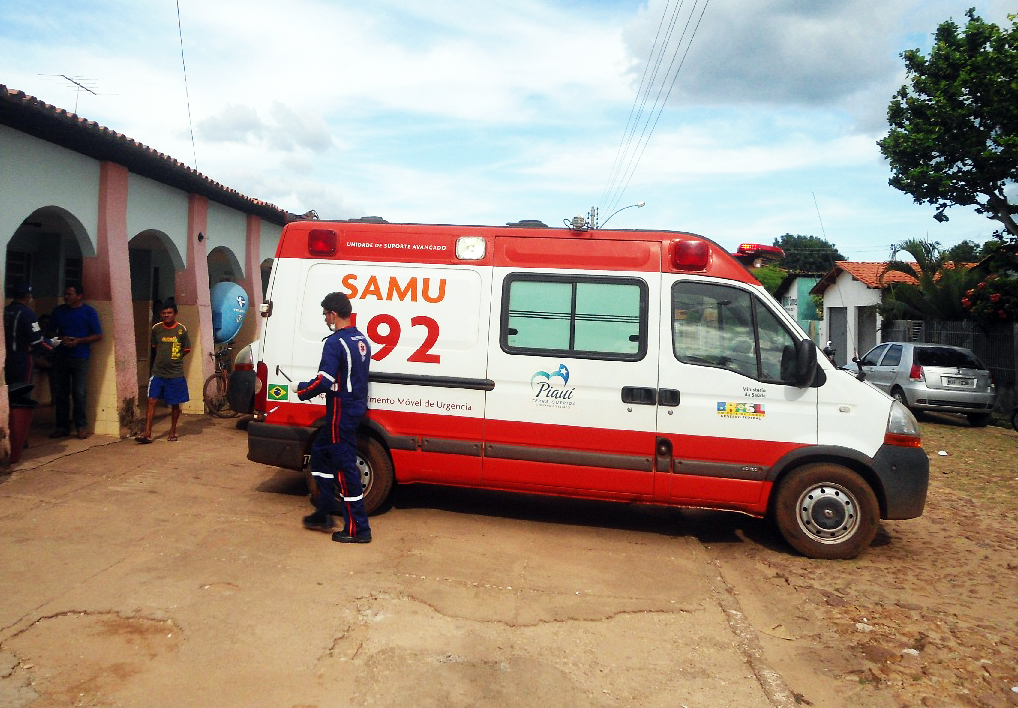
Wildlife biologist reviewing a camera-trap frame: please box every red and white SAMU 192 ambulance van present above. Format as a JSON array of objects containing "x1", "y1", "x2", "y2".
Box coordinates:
[{"x1": 247, "y1": 221, "x2": 929, "y2": 558}]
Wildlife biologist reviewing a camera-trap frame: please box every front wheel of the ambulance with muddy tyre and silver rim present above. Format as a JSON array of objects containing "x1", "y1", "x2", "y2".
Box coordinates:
[{"x1": 774, "y1": 462, "x2": 880, "y2": 560}]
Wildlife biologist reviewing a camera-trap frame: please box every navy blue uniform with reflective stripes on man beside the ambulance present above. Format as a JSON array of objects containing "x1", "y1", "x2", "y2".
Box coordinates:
[{"x1": 297, "y1": 327, "x2": 372, "y2": 536}]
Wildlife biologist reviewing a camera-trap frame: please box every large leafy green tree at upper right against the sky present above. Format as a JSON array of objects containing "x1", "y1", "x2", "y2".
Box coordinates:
[{"x1": 878, "y1": 8, "x2": 1018, "y2": 238}]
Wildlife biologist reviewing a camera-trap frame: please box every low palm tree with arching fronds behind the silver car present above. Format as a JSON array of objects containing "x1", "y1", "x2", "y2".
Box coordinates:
[{"x1": 881, "y1": 238, "x2": 976, "y2": 322}]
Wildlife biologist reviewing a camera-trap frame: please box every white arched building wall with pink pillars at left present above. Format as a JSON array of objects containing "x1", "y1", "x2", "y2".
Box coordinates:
[{"x1": 0, "y1": 125, "x2": 282, "y2": 454}]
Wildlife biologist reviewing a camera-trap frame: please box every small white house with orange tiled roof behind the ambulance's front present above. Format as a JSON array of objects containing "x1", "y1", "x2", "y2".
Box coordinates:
[{"x1": 809, "y1": 261, "x2": 916, "y2": 366}]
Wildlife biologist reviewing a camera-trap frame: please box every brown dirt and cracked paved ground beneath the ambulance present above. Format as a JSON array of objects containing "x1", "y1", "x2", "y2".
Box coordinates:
[{"x1": 0, "y1": 409, "x2": 1018, "y2": 708}]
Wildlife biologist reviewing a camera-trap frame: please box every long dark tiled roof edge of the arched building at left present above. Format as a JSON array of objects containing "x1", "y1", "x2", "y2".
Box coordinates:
[{"x1": 0, "y1": 84, "x2": 293, "y2": 225}]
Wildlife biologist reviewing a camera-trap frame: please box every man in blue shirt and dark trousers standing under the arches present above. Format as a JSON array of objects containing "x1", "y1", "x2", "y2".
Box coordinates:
[{"x1": 50, "y1": 284, "x2": 103, "y2": 440}]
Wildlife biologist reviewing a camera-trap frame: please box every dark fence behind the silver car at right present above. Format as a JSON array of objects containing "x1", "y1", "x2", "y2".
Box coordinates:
[{"x1": 884, "y1": 320, "x2": 1018, "y2": 412}]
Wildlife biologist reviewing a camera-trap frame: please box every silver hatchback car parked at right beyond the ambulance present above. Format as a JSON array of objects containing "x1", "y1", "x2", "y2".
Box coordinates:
[{"x1": 858, "y1": 341, "x2": 997, "y2": 426}]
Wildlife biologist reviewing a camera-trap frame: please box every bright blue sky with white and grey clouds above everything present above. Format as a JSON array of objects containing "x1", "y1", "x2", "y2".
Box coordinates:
[{"x1": 0, "y1": 0, "x2": 1014, "y2": 261}]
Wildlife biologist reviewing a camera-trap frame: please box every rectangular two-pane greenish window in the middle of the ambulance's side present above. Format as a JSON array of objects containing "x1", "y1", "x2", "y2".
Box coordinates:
[{"x1": 501, "y1": 273, "x2": 648, "y2": 362}]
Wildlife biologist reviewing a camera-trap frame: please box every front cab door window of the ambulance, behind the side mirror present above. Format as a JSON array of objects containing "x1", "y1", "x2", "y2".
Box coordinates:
[{"x1": 672, "y1": 282, "x2": 795, "y2": 382}]
